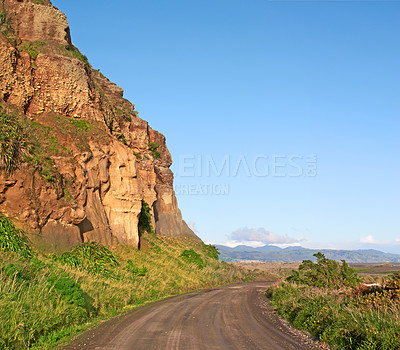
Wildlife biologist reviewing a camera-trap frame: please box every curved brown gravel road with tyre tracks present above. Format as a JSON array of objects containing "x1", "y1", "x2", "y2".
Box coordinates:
[{"x1": 62, "y1": 282, "x2": 322, "y2": 350}]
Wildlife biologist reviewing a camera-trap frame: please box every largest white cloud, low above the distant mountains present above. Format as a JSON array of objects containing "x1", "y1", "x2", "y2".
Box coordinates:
[{"x1": 229, "y1": 227, "x2": 299, "y2": 246}]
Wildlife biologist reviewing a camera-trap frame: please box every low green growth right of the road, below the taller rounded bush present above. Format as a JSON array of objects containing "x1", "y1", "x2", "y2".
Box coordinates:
[{"x1": 269, "y1": 282, "x2": 400, "y2": 350}]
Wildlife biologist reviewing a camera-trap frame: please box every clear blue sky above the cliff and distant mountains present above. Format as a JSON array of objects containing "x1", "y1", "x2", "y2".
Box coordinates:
[{"x1": 53, "y1": 0, "x2": 400, "y2": 253}]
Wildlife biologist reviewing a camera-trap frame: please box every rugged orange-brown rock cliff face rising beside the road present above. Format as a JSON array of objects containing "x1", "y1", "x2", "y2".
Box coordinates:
[{"x1": 0, "y1": 0, "x2": 196, "y2": 247}]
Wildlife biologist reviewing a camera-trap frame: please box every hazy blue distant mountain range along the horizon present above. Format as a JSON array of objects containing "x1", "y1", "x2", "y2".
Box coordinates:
[{"x1": 216, "y1": 245, "x2": 400, "y2": 263}]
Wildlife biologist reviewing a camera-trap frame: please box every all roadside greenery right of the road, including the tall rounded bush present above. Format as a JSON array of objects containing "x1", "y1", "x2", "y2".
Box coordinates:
[{"x1": 267, "y1": 253, "x2": 400, "y2": 350}]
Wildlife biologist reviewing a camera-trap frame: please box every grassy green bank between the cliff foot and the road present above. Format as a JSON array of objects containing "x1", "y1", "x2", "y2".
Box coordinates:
[{"x1": 0, "y1": 216, "x2": 260, "y2": 349}]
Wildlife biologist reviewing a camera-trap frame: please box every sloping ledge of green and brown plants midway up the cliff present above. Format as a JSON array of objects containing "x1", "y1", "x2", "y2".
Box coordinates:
[{"x1": 0, "y1": 104, "x2": 106, "y2": 202}]
